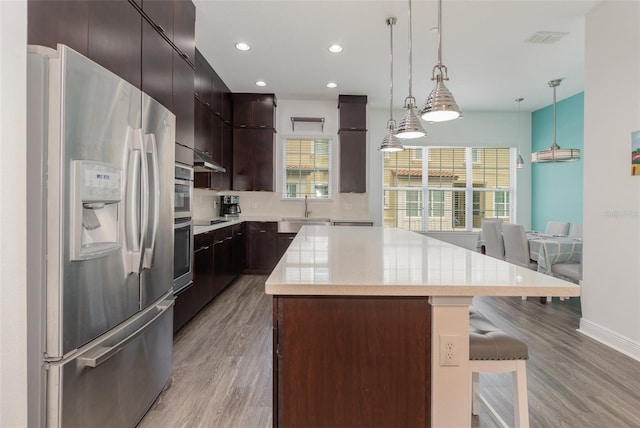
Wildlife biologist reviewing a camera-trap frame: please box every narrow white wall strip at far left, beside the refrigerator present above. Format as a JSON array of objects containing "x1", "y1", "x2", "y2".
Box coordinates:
[{"x1": 0, "y1": 0, "x2": 27, "y2": 427}]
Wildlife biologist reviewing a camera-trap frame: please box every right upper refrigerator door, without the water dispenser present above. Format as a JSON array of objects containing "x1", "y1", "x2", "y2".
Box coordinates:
[{"x1": 140, "y1": 94, "x2": 176, "y2": 308}]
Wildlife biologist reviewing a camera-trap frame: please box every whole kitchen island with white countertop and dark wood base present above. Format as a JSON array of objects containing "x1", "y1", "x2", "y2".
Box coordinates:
[{"x1": 265, "y1": 226, "x2": 579, "y2": 428}]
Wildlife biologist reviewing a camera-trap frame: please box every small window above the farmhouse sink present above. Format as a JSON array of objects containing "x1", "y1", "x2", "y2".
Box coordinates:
[{"x1": 282, "y1": 138, "x2": 331, "y2": 199}]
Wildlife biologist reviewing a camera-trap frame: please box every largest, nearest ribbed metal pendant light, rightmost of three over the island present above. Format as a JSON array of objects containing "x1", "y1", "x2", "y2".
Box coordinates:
[{"x1": 420, "y1": 0, "x2": 460, "y2": 122}]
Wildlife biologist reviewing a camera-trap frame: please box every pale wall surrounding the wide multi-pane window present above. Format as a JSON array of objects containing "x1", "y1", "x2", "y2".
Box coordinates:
[{"x1": 367, "y1": 105, "x2": 531, "y2": 231}]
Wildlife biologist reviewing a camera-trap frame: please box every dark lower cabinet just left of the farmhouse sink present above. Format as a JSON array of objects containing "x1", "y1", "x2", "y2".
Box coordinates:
[{"x1": 244, "y1": 221, "x2": 278, "y2": 274}]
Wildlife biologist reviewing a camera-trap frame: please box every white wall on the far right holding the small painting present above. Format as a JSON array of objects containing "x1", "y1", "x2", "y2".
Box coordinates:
[{"x1": 580, "y1": 1, "x2": 640, "y2": 360}]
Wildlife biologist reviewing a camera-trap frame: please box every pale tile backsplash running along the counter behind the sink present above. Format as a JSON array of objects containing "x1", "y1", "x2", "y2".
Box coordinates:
[{"x1": 193, "y1": 189, "x2": 370, "y2": 220}]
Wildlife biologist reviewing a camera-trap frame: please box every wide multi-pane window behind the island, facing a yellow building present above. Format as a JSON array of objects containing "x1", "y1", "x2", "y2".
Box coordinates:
[{"x1": 383, "y1": 147, "x2": 515, "y2": 231}]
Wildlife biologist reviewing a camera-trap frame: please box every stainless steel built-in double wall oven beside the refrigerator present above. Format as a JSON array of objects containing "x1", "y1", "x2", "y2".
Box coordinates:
[{"x1": 173, "y1": 164, "x2": 193, "y2": 293}]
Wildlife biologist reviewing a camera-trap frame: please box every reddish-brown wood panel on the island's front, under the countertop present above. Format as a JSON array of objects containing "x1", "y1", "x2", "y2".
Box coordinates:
[{"x1": 273, "y1": 296, "x2": 431, "y2": 427}]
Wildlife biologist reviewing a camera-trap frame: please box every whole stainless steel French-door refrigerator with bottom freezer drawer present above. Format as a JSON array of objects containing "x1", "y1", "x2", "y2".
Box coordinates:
[{"x1": 27, "y1": 45, "x2": 175, "y2": 427}]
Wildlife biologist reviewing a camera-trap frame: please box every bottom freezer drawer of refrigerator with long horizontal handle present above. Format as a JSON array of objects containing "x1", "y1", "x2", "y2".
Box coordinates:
[{"x1": 46, "y1": 293, "x2": 173, "y2": 428}]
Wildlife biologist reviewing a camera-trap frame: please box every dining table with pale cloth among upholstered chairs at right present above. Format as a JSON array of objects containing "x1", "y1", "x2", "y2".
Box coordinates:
[{"x1": 527, "y1": 231, "x2": 582, "y2": 275}]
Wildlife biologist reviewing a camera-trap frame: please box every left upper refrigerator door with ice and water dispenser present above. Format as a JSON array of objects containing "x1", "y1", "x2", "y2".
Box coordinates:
[{"x1": 45, "y1": 45, "x2": 142, "y2": 359}]
